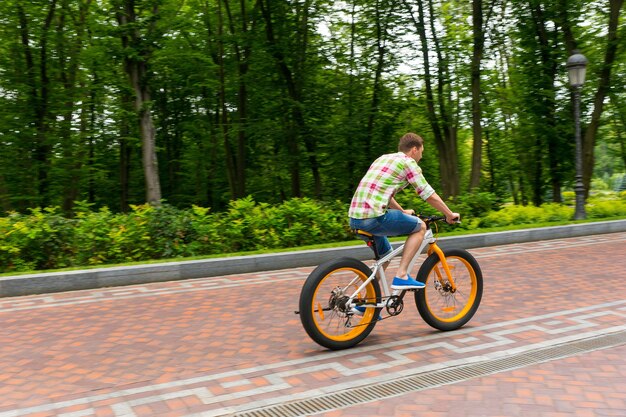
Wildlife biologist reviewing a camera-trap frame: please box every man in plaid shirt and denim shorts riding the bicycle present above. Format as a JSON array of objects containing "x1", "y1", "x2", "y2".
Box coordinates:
[{"x1": 348, "y1": 133, "x2": 460, "y2": 290}]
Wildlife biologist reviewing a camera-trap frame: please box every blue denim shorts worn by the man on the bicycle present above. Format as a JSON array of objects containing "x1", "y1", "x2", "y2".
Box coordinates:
[{"x1": 350, "y1": 210, "x2": 422, "y2": 257}]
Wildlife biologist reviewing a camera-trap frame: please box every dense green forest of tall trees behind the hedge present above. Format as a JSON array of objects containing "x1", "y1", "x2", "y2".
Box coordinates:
[{"x1": 0, "y1": 0, "x2": 626, "y2": 267}]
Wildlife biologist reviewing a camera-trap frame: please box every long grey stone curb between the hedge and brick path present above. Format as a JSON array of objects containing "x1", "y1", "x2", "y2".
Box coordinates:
[{"x1": 0, "y1": 220, "x2": 626, "y2": 297}]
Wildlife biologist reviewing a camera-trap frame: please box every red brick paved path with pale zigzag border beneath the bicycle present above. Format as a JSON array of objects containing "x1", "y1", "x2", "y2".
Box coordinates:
[{"x1": 0, "y1": 233, "x2": 626, "y2": 417}]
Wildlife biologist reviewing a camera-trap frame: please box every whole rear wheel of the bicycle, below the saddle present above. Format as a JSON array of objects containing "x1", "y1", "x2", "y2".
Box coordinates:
[{"x1": 300, "y1": 258, "x2": 380, "y2": 350}]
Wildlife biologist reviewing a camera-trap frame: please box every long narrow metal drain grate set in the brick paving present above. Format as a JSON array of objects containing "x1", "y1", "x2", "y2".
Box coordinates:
[{"x1": 235, "y1": 331, "x2": 626, "y2": 417}]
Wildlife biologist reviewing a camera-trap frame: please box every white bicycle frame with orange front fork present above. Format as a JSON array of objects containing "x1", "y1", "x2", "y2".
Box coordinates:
[{"x1": 344, "y1": 227, "x2": 456, "y2": 308}]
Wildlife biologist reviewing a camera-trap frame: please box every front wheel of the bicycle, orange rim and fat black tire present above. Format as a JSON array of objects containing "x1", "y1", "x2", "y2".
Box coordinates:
[{"x1": 415, "y1": 249, "x2": 483, "y2": 331}]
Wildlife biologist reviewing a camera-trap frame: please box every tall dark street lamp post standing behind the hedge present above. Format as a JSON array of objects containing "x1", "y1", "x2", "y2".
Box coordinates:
[{"x1": 567, "y1": 50, "x2": 588, "y2": 220}]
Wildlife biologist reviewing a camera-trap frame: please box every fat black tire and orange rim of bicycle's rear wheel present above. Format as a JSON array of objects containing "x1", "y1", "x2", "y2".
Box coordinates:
[{"x1": 299, "y1": 258, "x2": 381, "y2": 350}]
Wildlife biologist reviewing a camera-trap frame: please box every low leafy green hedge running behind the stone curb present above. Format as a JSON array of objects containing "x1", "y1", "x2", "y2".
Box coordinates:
[{"x1": 0, "y1": 194, "x2": 626, "y2": 272}]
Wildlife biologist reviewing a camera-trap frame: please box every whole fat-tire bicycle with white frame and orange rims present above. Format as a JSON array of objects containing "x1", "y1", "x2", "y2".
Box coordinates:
[{"x1": 296, "y1": 215, "x2": 483, "y2": 350}]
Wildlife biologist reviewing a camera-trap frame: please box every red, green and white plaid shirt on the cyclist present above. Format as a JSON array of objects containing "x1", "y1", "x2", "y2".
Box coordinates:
[{"x1": 348, "y1": 152, "x2": 435, "y2": 219}]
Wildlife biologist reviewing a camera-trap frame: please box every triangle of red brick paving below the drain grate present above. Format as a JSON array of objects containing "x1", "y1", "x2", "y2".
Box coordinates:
[{"x1": 316, "y1": 346, "x2": 626, "y2": 417}]
